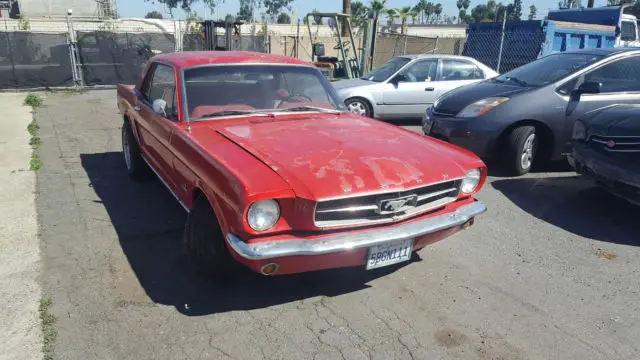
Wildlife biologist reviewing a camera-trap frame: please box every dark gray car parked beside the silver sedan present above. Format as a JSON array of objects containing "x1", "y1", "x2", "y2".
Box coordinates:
[{"x1": 422, "y1": 48, "x2": 640, "y2": 175}]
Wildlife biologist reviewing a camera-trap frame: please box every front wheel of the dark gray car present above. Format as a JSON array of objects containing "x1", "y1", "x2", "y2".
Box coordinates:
[{"x1": 505, "y1": 126, "x2": 538, "y2": 176}]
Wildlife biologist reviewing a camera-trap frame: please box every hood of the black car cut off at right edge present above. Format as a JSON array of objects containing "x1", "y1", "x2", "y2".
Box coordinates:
[{"x1": 588, "y1": 105, "x2": 640, "y2": 136}]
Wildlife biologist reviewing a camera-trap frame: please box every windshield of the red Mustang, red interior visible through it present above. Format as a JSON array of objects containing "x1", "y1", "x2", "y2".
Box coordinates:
[{"x1": 184, "y1": 65, "x2": 345, "y2": 120}]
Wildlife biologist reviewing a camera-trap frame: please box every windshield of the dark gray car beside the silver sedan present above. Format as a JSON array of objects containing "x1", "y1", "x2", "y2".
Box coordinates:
[{"x1": 495, "y1": 53, "x2": 604, "y2": 87}]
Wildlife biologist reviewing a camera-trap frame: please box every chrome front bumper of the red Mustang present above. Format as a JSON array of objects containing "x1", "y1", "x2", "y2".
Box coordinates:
[{"x1": 227, "y1": 201, "x2": 487, "y2": 260}]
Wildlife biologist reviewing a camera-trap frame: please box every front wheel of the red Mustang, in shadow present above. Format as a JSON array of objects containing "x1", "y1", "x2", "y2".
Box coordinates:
[{"x1": 184, "y1": 196, "x2": 242, "y2": 280}]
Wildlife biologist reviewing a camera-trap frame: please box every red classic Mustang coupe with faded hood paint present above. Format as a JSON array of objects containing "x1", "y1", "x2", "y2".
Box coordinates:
[{"x1": 118, "y1": 52, "x2": 487, "y2": 277}]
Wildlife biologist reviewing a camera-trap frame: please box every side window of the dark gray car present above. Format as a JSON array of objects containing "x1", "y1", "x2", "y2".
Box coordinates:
[{"x1": 584, "y1": 56, "x2": 640, "y2": 93}]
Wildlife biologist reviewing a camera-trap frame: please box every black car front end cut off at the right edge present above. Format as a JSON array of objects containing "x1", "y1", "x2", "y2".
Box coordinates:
[{"x1": 567, "y1": 105, "x2": 640, "y2": 205}]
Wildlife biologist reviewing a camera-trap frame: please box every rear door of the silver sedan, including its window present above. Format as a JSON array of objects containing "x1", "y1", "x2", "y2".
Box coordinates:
[{"x1": 436, "y1": 59, "x2": 484, "y2": 96}]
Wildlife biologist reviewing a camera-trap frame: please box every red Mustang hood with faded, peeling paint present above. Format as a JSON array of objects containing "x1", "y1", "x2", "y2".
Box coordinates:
[{"x1": 216, "y1": 113, "x2": 476, "y2": 200}]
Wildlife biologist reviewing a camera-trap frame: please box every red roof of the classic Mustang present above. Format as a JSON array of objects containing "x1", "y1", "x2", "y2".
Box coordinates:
[{"x1": 152, "y1": 51, "x2": 311, "y2": 68}]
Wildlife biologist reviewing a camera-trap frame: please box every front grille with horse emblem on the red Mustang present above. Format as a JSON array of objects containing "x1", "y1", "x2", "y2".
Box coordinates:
[{"x1": 314, "y1": 179, "x2": 462, "y2": 227}]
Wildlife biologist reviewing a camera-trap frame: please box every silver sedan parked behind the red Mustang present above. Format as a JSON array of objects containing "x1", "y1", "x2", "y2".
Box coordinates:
[{"x1": 332, "y1": 55, "x2": 498, "y2": 120}]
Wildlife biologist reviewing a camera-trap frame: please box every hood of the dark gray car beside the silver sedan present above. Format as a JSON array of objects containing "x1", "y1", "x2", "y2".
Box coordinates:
[{"x1": 434, "y1": 80, "x2": 534, "y2": 115}]
